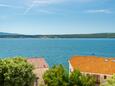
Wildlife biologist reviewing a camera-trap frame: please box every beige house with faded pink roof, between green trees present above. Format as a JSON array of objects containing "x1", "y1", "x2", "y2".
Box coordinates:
[{"x1": 27, "y1": 58, "x2": 48, "y2": 86}]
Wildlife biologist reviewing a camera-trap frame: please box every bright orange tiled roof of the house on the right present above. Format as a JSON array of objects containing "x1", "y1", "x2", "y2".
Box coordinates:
[{"x1": 70, "y1": 56, "x2": 115, "y2": 75}]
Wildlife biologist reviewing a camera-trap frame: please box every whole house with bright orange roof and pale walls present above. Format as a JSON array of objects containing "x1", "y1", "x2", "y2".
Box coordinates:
[{"x1": 69, "y1": 56, "x2": 115, "y2": 84}]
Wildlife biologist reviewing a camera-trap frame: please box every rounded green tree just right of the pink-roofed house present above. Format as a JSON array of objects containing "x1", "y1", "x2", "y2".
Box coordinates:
[{"x1": 43, "y1": 65, "x2": 69, "y2": 86}]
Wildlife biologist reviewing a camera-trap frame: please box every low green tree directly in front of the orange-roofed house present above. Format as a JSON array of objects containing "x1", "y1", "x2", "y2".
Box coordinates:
[{"x1": 70, "y1": 70, "x2": 96, "y2": 86}]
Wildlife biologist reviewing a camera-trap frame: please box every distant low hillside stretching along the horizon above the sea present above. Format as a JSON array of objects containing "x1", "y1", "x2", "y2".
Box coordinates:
[{"x1": 0, "y1": 32, "x2": 115, "y2": 38}]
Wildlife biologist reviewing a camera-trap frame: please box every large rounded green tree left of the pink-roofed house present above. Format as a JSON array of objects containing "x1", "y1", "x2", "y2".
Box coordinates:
[{"x1": 0, "y1": 58, "x2": 35, "y2": 86}]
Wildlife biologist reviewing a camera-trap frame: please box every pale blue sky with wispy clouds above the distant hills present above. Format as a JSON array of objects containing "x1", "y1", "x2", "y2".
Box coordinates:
[{"x1": 0, "y1": 0, "x2": 115, "y2": 34}]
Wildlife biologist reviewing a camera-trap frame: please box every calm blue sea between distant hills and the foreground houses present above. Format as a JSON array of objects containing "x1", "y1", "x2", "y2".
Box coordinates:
[{"x1": 0, "y1": 38, "x2": 115, "y2": 66}]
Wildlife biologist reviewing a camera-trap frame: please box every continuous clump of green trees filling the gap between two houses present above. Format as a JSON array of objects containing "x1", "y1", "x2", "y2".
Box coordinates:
[{"x1": 43, "y1": 65, "x2": 95, "y2": 86}]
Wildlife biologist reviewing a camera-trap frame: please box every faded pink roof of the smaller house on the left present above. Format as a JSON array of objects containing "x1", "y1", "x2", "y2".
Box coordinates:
[{"x1": 27, "y1": 58, "x2": 48, "y2": 68}]
